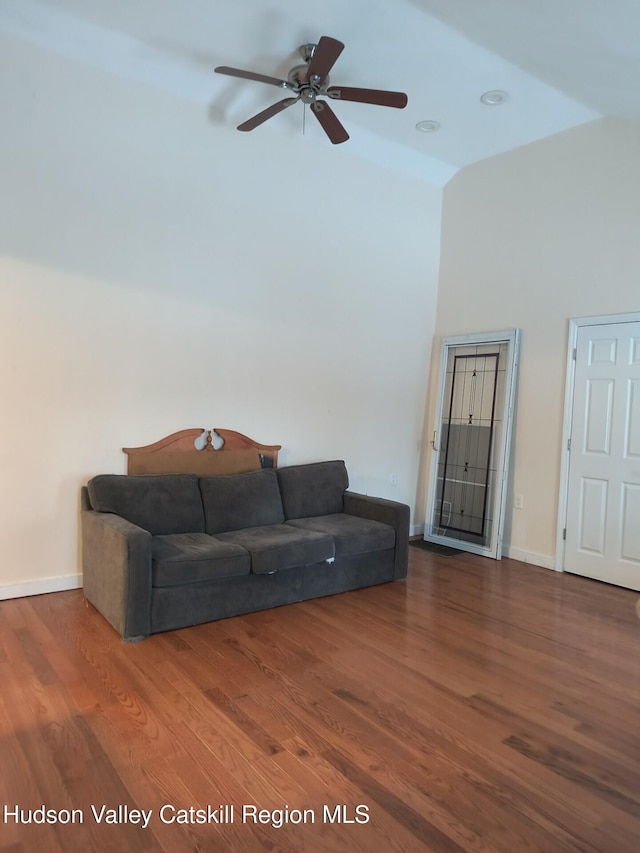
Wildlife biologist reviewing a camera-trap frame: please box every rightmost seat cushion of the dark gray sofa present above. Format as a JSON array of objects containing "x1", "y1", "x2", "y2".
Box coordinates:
[{"x1": 286, "y1": 512, "x2": 396, "y2": 557}]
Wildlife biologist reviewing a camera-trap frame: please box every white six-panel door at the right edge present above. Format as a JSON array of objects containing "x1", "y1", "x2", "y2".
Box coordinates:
[{"x1": 564, "y1": 322, "x2": 640, "y2": 590}]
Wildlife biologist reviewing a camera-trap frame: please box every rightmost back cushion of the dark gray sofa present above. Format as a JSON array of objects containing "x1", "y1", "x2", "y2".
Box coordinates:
[{"x1": 278, "y1": 460, "x2": 349, "y2": 519}]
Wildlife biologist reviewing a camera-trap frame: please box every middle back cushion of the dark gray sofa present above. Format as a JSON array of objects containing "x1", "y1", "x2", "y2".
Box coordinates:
[{"x1": 200, "y1": 468, "x2": 284, "y2": 535}]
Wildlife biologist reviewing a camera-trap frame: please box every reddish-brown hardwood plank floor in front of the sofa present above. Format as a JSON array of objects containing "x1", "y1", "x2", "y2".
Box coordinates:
[{"x1": 0, "y1": 548, "x2": 640, "y2": 853}]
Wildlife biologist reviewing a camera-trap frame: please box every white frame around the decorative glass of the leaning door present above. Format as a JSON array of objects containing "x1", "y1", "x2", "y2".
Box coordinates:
[{"x1": 423, "y1": 329, "x2": 520, "y2": 560}]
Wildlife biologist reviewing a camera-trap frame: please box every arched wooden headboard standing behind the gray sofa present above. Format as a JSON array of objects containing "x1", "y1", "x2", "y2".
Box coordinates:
[{"x1": 122, "y1": 429, "x2": 281, "y2": 476}]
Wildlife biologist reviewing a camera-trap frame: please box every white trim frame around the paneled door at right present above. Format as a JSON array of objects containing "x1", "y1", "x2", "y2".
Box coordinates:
[{"x1": 555, "y1": 311, "x2": 640, "y2": 572}]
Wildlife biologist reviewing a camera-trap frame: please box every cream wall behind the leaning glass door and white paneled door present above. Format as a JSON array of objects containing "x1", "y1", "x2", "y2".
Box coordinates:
[{"x1": 424, "y1": 115, "x2": 640, "y2": 566}]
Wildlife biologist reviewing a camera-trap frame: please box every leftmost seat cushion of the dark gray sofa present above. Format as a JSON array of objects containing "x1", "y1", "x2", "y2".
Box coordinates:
[{"x1": 151, "y1": 533, "x2": 251, "y2": 586}]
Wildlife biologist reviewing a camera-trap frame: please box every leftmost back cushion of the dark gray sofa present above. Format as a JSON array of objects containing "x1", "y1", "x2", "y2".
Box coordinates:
[{"x1": 88, "y1": 474, "x2": 204, "y2": 536}]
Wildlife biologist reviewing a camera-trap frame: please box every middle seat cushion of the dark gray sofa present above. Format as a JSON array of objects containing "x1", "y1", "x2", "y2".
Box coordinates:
[{"x1": 216, "y1": 524, "x2": 335, "y2": 575}]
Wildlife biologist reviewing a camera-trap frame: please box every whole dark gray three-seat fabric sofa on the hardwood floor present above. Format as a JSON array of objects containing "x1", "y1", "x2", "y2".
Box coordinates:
[{"x1": 81, "y1": 461, "x2": 409, "y2": 640}]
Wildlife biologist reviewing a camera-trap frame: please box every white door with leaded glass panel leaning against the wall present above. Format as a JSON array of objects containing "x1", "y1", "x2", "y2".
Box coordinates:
[{"x1": 424, "y1": 329, "x2": 520, "y2": 559}]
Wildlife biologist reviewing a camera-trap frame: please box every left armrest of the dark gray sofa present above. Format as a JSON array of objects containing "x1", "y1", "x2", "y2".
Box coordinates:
[{"x1": 80, "y1": 508, "x2": 151, "y2": 640}]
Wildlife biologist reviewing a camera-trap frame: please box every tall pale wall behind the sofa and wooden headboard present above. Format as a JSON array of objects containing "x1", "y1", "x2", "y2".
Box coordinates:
[{"x1": 0, "y1": 39, "x2": 441, "y2": 596}]
